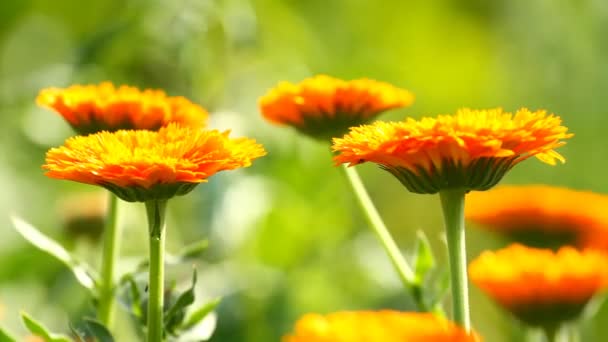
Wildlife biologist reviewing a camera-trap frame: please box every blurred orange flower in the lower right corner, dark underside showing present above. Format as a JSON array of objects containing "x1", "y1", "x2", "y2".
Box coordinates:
[{"x1": 469, "y1": 244, "x2": 608, "y2": 326}]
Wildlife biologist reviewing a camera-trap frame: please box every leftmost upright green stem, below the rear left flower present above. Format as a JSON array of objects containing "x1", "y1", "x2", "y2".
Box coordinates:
[{"x1": 97, "y1": 192, "x2": 121, "y2": 330}]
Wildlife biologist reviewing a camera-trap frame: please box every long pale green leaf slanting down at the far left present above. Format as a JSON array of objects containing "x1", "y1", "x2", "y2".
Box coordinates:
[{"x1": 11, "y1": 216, "x2": 96, "y2": 290}]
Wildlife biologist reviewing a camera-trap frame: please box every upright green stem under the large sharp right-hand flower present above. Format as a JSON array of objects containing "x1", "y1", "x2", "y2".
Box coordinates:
[{"x1": 439, "y1": 189, "x2": 471, "y2": 331}]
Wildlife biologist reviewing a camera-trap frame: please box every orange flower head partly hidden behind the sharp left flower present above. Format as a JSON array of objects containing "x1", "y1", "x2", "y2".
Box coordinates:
[{"x1": 36, "y1": 82, "x2": 208, "y2": 134}]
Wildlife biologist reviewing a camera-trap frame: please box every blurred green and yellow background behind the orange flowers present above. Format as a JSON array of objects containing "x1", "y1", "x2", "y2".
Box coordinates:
[{"x1": 0, "y1": 0, "x2": 608, "y2": 342}]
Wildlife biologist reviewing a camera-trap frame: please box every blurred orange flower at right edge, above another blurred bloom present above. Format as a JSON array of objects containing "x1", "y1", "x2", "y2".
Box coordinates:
[{"x1": 465, "y1": 185, "x2": 608, "y2": 249}]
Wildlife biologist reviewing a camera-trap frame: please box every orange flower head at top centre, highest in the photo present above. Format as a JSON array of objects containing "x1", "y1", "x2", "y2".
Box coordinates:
[{"x1": 259, "y1": 75, "x2": 414, "y2": 140}]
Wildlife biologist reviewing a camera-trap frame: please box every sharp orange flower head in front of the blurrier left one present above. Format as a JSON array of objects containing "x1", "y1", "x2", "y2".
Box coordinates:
[{"x1": 43, "y1": 124, "x2": 265, "y2": 202}]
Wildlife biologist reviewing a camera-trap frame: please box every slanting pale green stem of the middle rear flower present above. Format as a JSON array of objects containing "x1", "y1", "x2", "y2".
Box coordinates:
[{"x1": 344, "y1": 166, "x2": 420, "y2": 292}]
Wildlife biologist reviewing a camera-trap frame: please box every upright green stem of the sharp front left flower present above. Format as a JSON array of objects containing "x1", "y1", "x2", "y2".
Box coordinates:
[{"x1": 146, "y1": 200, "x2": 167, "y2": 342}]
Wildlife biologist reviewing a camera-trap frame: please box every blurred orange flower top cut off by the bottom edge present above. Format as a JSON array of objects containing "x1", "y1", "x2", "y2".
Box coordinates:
[{"x1": 283, "y1": 310, "x2": 480, "y2": 342}]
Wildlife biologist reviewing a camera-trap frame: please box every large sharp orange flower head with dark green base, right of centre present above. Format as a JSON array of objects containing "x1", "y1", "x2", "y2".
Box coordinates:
[{"x1": 333, "y1": 108, "x2": 572, "y2": 193}]
